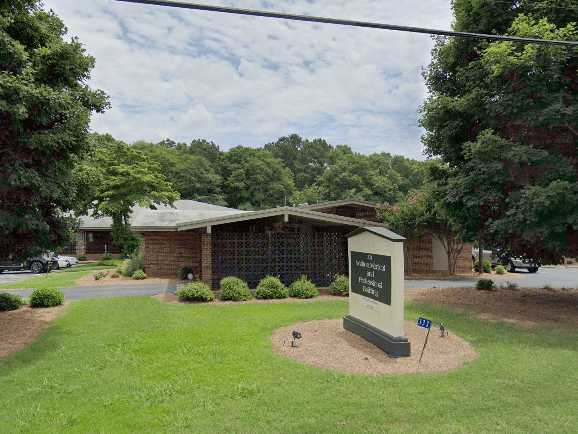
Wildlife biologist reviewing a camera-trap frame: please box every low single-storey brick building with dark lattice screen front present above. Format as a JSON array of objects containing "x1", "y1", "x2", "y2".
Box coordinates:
[{"x1": 76, "y1": 201, "x2": 471, "y2": 288}]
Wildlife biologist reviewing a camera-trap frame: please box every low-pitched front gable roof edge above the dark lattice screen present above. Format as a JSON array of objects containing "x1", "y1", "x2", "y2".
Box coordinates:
[{"x1": 177, "y1": 207, "x2": 384, "y2": 231}]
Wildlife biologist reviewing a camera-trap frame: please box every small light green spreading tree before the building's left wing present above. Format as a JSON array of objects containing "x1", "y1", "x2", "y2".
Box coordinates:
[{"x1": 75, "y1": 134, "x2": 179, "y2": 255}]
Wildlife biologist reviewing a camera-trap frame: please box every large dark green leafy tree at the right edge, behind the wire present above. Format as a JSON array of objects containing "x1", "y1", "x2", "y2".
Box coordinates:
[{"x1": 422, "y1": 0, "x2": 578, "y2": 260}]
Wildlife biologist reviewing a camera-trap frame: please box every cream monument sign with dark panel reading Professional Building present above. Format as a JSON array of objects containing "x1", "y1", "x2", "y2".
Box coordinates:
[{"x1": 343, "y1": 227, "x2": 410, "y2": 357}]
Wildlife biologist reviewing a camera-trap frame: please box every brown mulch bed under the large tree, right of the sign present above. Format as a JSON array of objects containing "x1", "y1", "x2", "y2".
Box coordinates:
[{"x1": 407, "y1": 288, "x2": 578, "y2": 327}]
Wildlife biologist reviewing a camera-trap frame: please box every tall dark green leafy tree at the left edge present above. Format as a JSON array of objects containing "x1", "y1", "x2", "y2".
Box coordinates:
[{"x1": 0, "y1": 0, "x2": 108, "y2": 257}]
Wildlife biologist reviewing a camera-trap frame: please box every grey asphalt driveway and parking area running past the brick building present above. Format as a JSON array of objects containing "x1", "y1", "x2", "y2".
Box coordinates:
[{"x1": 0, "y1": 267, "x2": 578, "y2": 300}]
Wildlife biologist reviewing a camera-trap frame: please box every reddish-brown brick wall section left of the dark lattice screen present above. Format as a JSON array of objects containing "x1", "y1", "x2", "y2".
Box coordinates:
[{"x1": 142, "y1": 231, "x2": 201, "y2": 279}]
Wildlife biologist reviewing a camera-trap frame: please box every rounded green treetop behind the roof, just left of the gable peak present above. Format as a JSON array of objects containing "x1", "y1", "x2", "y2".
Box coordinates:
[{"x1": 223, "y1": 146, "x2": 295, "y2": 209}]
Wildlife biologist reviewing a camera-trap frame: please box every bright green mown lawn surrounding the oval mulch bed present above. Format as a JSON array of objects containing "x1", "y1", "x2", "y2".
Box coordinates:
[{"x1": 0, "y1": 298, "x2": 578, "y2": 433}]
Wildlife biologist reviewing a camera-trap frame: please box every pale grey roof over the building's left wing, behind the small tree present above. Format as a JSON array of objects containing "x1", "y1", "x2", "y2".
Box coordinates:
[{"x1": 79, "y1": 200, "x2": 246, "y2": 231}]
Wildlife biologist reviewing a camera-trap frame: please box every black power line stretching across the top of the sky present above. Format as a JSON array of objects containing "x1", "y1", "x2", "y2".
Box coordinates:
[{"x1": 117, "y1": 0, "x2": 578, "y2": 47}]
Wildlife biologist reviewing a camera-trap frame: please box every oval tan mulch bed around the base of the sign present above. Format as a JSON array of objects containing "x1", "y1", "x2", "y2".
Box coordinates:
[{"x1": 271, "y1": 319, "x2": 478, "y2": 375}]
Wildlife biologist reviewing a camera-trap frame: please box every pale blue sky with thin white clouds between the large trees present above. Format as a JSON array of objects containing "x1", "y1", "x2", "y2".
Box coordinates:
[{"x1": 44, "y1": 0, "x2": 452, "y2": 158}]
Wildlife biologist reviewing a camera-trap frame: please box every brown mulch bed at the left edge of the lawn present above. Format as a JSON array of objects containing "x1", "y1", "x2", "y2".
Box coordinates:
[{"x1": 0, "y1": 304, "x2": 67, "y2": 358}]
